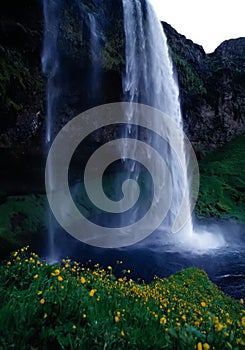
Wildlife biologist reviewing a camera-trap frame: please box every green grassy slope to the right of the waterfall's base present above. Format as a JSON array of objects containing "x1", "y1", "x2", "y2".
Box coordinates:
[{"x1": 196, "y1": 134, "x2": 245, "y2": 223}]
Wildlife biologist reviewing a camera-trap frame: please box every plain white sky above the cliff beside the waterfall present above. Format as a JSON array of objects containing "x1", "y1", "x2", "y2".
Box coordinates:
[{"x1": 150, "y1": 0, "x2": 245, "y2": 53}]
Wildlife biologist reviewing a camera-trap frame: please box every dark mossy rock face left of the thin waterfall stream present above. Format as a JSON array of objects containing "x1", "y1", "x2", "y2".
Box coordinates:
[{"x1": 0, "y1": 0, "x2": 45, "y2": 150}]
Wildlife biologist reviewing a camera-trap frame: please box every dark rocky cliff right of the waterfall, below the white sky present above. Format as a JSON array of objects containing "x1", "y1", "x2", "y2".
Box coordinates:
[{"x1": 163, "y1": 23, "x2": 245, "y2": 151}]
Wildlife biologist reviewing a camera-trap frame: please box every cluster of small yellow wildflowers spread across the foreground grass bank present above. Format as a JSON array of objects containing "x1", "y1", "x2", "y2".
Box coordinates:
[{"x1": 4, "y1": 247, "x2": 245, "y2": 350}]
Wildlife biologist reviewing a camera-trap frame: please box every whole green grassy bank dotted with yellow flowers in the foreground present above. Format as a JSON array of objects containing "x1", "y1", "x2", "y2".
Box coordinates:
[{"x1": 0, "y1": 247, "x2": 245, "y2": 350}]
